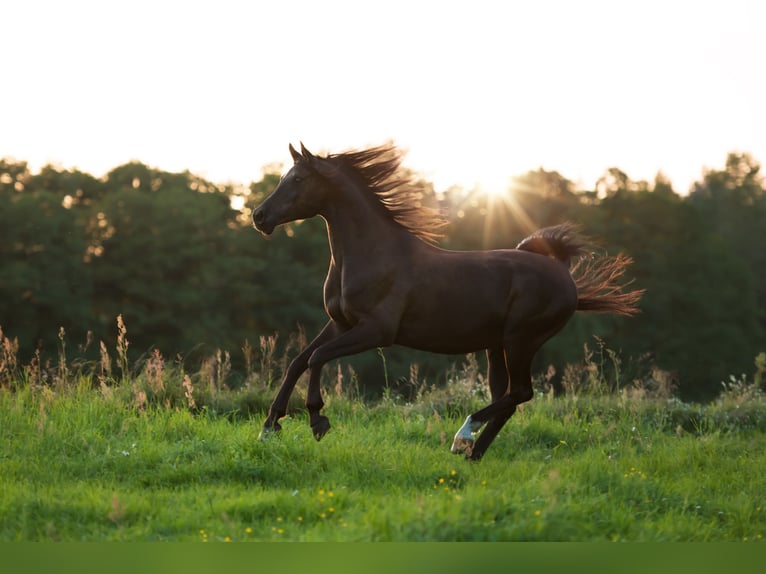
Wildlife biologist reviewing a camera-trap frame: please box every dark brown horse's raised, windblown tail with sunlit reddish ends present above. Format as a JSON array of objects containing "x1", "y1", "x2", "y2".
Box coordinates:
[{"x1": 516, "y1": 223, "x2": 644, "y2": 316}]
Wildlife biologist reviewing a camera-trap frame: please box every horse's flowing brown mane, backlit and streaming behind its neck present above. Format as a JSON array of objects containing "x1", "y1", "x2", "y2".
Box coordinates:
[{"x1": 326, "y1": 143, "x2": 446, "y2": 243}]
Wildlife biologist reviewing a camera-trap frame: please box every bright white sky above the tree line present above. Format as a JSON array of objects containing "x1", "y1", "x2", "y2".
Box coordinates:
[{"x1": 0, "y1": 0, "x2": 766, "y2": 196}]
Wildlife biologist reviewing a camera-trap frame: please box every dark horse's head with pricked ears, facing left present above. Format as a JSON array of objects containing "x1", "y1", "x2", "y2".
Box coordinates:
[{"x1": 253, "y1": 143, "x2": 331, "y2": 235}]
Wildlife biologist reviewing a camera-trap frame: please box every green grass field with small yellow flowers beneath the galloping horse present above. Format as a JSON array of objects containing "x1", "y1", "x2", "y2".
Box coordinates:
[{"x1": 0, "y1": 364, "x2": 766, "y2": 542}]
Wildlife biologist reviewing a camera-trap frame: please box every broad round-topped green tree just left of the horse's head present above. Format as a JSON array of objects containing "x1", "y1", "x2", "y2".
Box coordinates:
[{"x1": 90, "y1": 163, "x2": 236, "y2": 353}]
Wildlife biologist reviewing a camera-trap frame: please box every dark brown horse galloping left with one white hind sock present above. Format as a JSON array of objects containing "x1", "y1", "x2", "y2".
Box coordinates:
[{"x1": 253, "y1": 144, "x2": 641, "y2": 459}]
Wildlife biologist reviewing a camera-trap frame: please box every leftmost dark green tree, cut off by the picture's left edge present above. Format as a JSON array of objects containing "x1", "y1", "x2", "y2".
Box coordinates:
[{"x1": 0, "y1": 162, "x2": 93, "y2": 356}]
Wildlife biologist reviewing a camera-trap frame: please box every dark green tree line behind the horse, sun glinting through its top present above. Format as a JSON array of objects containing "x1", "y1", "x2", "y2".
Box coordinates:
[{"x1": 0, "y1": 153, "x2": 766, "y2": 399}]
